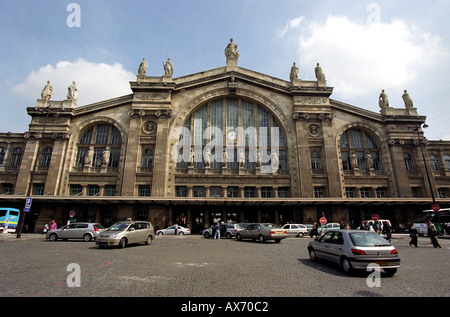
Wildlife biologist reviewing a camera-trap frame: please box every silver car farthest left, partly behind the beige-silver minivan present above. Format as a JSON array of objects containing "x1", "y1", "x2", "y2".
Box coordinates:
[{"x1": 45, "y1": 222, "x2": 105, "y2": 242}]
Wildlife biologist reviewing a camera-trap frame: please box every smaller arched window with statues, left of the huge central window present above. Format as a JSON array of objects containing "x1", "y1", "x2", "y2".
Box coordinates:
[{"x1": 75, "y1": 124, "x2": 122, "y2": 167}]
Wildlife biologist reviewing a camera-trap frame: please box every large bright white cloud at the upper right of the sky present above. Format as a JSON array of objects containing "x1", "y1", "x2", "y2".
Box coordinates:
[{"x1": 278, "y1": 16, "x2": 441, "y2": 100}]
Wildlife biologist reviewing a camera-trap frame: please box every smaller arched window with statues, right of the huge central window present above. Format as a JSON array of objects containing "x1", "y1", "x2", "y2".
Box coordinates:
[{"x1": 340, "y1": 129, "x2": 381, "y2": 170}]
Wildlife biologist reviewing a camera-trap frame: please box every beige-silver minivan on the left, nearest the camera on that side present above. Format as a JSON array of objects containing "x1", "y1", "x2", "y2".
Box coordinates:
[{"x1": 95, "y1": 221, "x2": 155, "y2": 248}]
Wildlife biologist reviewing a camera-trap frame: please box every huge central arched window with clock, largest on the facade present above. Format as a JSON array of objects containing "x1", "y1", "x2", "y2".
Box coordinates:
[{"x1": 177, "y1": 97, "x2": 287, "y2": 172}]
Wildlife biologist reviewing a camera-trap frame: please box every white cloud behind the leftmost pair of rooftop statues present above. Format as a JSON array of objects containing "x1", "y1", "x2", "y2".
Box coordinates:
[{"x1": 13, "y1": 58, "x2": 136, "y2": 106}]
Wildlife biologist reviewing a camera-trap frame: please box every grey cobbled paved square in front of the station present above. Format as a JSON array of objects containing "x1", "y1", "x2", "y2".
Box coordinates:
[{"x1": 0, "y1": 230, "x2": 450, "y2": 297}]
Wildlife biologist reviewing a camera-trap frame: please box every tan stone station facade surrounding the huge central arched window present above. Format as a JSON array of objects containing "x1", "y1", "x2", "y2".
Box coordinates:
[{"x1": 0, "y1": 66, "x2": 450, "y2": 231}]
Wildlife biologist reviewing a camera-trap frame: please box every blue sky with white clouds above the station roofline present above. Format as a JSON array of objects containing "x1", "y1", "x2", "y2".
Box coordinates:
[{"x1": 0, "y1": 0, "x2": 450, "y2": 140}]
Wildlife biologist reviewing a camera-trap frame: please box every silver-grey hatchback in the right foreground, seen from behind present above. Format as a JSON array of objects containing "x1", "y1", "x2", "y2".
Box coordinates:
[{"x1": 308, "y1": 230, "x2": 400, "y2": 275}]
